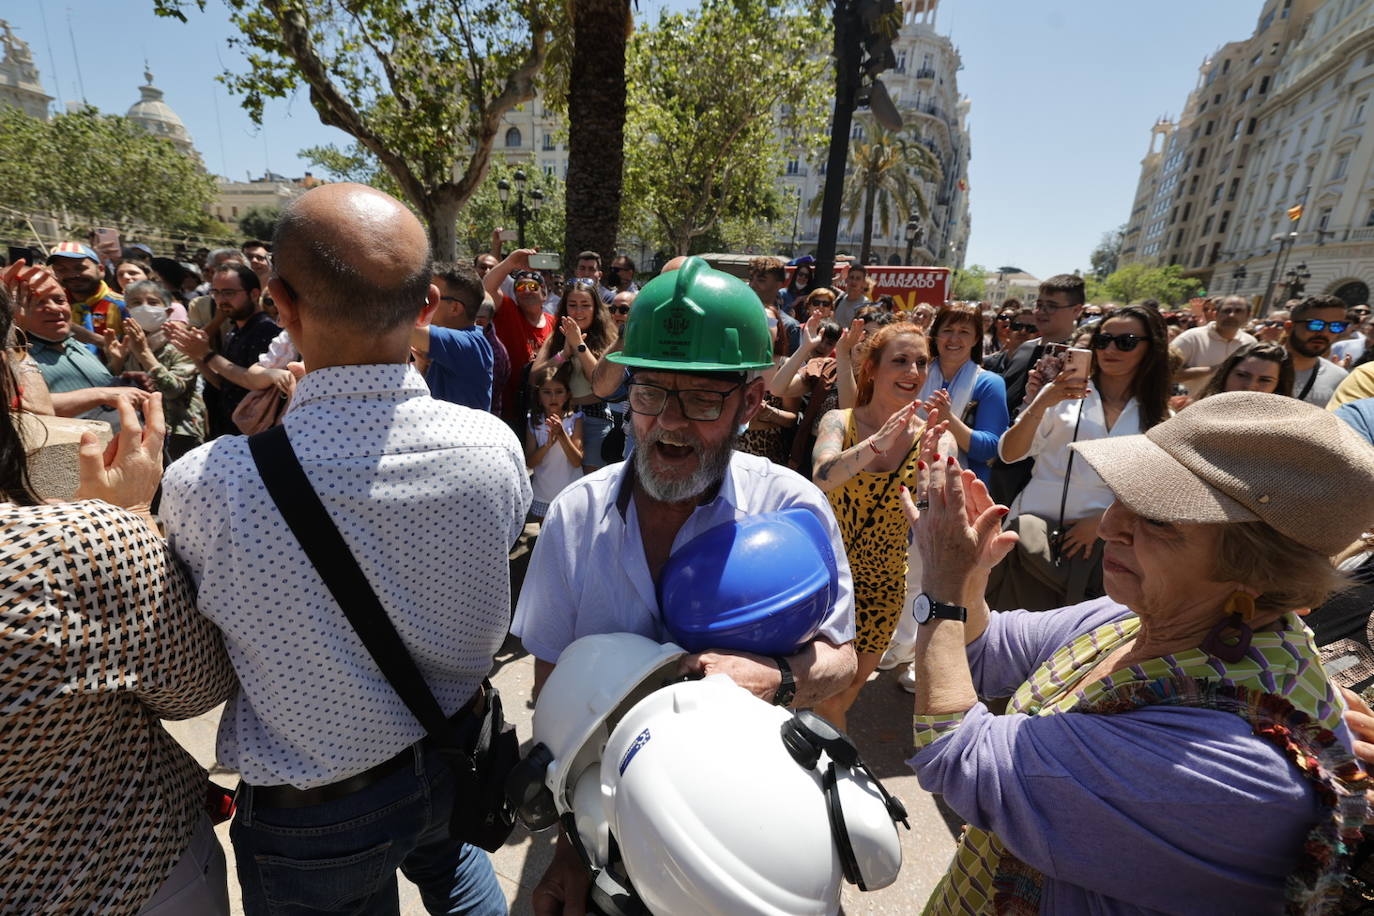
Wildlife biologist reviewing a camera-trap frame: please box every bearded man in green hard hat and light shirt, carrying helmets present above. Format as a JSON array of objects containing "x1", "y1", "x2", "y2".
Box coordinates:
[{"x1": 511, "y1": 258, "x2": 856, "y2": 913}]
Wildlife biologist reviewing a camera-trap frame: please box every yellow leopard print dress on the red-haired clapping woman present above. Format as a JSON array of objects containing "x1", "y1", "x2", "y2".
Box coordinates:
[{"x1": 827, "y1": 411, "x2": 919, "y2": 654}]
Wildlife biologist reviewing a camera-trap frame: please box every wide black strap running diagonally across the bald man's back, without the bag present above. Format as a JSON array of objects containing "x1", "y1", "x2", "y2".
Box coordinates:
[{"x1": 249, "y1": 426, "x2": 458, "y2": 746}]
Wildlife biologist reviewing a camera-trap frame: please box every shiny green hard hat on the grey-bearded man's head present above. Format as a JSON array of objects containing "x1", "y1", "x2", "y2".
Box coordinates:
[{"x1": 606, "y1": 258, "x2": 774, "y2": 372}]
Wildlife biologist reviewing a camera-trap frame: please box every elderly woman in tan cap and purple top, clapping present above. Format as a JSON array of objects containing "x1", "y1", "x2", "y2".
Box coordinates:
[{"x1": 903, "y1": 393, "x2": 1374, "y2": 913}]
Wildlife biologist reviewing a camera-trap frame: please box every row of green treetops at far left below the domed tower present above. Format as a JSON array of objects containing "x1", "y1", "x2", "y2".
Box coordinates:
[{"x1": 0, "y1": 106, "x2": 214, "y2": 231}]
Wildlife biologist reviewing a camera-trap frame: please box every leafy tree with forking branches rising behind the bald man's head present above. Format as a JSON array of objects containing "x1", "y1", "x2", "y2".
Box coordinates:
[{"x1": 154, "y1": 0, "x2": 552, "y2": 257}]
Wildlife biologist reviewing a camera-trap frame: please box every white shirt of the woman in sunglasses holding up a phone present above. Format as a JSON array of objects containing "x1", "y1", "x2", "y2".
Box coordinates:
[{"x1": 998, "y1": 387, "x2": 1143, "y2": 525}]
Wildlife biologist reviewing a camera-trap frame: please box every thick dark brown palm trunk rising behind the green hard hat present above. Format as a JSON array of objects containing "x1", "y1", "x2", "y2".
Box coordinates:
[{"x1": 563, "y1": 0, "x2": 633, "y2": 264}]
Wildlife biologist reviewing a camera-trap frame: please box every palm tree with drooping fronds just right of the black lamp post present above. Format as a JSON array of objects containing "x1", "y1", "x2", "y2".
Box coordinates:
[{"x1": 818, "y1": 124, "x2": 941, "y2": 264}]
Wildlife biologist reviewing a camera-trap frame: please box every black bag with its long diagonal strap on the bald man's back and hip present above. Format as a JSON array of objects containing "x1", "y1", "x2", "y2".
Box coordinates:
[{"x1": 249, "y1": 426, "x2": 519, "y2": 851}]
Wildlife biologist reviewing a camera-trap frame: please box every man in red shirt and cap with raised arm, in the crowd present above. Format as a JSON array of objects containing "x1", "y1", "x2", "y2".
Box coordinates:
[{"x1": 482, "y1": 249, "x2": 554, "y2": 433}]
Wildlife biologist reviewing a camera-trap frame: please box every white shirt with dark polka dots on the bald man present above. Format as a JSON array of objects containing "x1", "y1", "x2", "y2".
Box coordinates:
[{"x1": 161, "y1": 364, "x2": 530, "y2": 788}]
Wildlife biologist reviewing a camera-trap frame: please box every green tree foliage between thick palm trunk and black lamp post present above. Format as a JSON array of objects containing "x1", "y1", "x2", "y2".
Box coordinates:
[{"x1": 621, "y1": 0, "x2": 829, "y2": 254}]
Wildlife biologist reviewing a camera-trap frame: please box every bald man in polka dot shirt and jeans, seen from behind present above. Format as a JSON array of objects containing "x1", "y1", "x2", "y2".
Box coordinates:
[{"x1": 162, "y1": 184, "x2": 530, "y2": 915}]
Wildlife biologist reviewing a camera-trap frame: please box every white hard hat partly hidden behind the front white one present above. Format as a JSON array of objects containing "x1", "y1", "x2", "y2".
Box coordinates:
[{"x1": 534, "y1": 633, "x2": 686, "y2": 814}]
